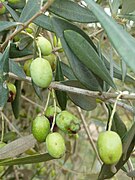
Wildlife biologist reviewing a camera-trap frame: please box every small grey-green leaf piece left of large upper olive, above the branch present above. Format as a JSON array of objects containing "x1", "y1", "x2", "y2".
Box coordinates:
[{"x1": 9, "y1": 59, "x2": 26, "y2": 79}]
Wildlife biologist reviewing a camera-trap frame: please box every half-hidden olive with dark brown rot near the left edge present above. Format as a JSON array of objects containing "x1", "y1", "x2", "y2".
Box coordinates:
[{"x1": 7, "y1": 82, "x2": 16, "y2": 102}]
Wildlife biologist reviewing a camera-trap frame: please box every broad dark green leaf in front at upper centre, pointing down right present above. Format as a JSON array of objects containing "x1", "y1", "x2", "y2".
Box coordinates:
[{"x1": 64, "y1": 30, "x2": 115, "y2": 88}]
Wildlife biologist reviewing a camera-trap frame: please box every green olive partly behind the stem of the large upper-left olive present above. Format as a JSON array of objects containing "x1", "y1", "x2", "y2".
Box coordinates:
[{"x1": 37, "y1": 37, "x2": 52, "y2": 56}]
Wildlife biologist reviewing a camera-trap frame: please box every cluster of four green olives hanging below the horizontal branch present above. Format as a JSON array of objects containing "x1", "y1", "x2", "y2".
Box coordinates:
[{"x1": 32, "y1": 106, "x2": 80, "y2": 158}]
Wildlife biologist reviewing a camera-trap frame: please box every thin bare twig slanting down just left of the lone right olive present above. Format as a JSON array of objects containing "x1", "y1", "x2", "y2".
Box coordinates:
[{"x1": 77, "y1": 107, "x2": 102, "y2": 164}]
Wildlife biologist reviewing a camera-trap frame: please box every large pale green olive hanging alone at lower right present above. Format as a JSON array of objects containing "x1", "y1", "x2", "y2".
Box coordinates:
[{"x1": 97, "y1": 131, "x2": 122, "y2": 164}]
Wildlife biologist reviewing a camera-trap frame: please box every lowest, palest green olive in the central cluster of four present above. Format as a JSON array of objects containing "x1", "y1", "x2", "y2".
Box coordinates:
[{"x1": 46, "y1": 132, "x2": 66, "y2": 158}]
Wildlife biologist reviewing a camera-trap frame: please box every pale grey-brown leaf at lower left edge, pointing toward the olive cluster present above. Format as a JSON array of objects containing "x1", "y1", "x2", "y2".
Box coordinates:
[{"x1": 0, "y1": 135, "x2": 36, "y2": 159}]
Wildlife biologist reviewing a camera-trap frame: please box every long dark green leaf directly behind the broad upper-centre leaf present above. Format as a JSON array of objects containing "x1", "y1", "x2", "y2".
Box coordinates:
[{"x1": 52, "y1": 17, "x2": 102, "y2": 91}]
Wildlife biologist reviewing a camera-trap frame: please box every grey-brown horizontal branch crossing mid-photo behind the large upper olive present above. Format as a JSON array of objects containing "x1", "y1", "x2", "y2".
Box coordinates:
[{"x1": 9, "y1": 73, "x2": 135, "y2": 114}]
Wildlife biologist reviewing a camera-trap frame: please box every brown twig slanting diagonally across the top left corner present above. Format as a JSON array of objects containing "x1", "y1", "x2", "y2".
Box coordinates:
[{"x1": 0, "y1": 0, "x2": 54, "y2": 52}]
